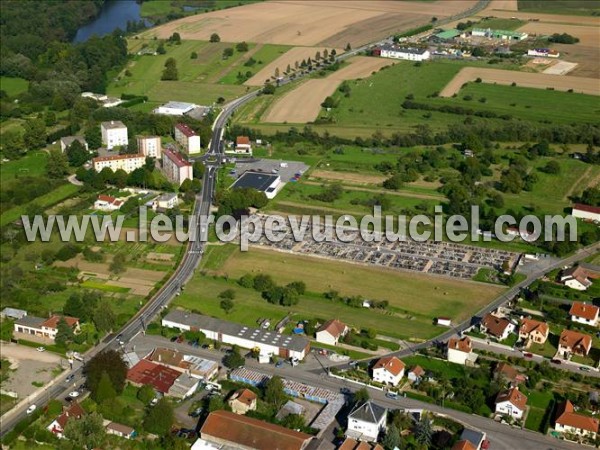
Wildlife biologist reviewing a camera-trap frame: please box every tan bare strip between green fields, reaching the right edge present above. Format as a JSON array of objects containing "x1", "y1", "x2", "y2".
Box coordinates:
[{"x1": 440, "y1": 67, "x2": 600, "y2": 97}]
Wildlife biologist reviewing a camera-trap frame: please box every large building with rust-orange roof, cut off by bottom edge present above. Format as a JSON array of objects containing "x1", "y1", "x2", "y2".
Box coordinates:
[{"x1": 200, "y1": 410, "x2": 313, "y2": 450}]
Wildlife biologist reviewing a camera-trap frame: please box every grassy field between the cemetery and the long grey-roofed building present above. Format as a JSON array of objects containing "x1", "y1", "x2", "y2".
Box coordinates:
[{"x1": 175, "y1": 248, "x2": 502, "y2": 339}]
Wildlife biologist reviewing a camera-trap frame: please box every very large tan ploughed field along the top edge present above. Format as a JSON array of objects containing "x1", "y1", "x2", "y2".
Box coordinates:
[{"x1": 141, "y1": 0, "x2": 475, "y2": 47}]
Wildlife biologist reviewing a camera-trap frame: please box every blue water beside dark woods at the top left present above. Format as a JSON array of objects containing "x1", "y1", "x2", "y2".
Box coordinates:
[{"x1": 73, "y1": 0, "x2": 142, "y2": 42}]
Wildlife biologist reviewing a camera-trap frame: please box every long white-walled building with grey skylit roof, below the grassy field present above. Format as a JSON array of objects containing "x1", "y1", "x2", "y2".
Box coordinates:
[{"x1": 162, "y1": 310, "x2": 310, "y2": 359}]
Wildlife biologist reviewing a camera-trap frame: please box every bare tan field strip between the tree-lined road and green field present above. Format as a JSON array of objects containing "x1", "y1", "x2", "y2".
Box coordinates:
[{"x1": 262, "y1": 56, "x2": 394, "y2": 123}]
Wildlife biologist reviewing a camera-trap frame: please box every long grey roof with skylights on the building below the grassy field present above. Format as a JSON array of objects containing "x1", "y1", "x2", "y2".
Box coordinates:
[{"x1": 163, "y1": 310, "x2": 309, "y2": 352}]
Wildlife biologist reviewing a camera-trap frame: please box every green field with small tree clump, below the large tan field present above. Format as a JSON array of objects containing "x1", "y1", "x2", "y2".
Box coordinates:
[{"x1": 107, "y1": 41, "x2": 251, "y2": 105}]
